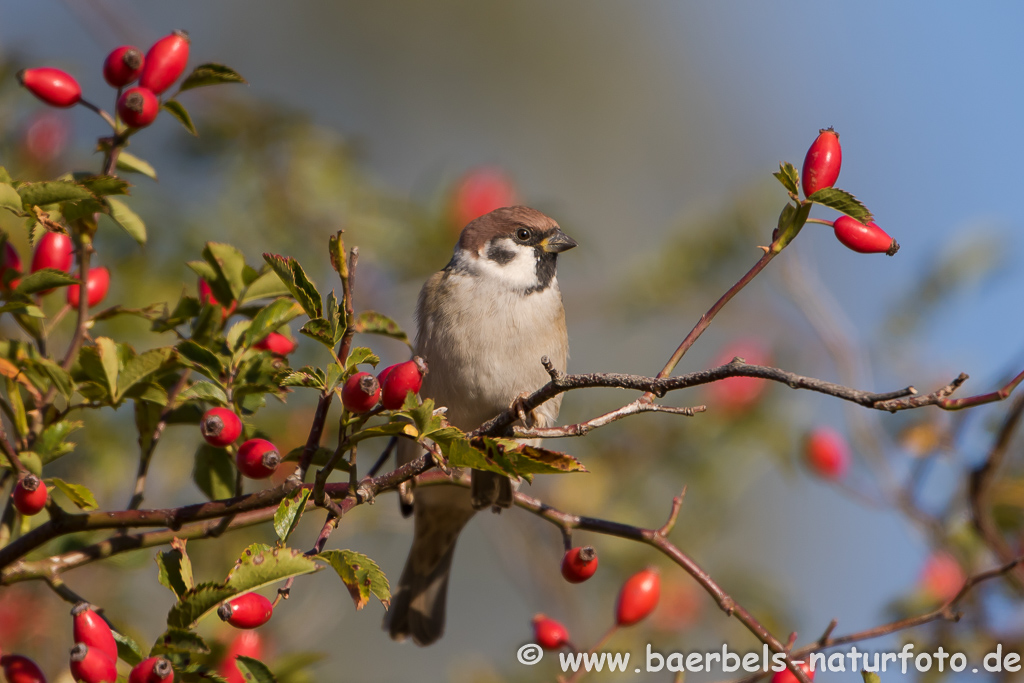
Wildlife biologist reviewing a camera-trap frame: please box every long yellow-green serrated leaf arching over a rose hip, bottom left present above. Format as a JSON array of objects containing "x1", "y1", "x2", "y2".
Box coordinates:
[{"x1": 167, "y1": 545, "x2": 321, "y2": 629}]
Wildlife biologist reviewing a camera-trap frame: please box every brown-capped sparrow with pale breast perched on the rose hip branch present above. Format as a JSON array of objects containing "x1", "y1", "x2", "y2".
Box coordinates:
[{"x1": 384, "y1": 206, "x2": 577, "y2": 645}]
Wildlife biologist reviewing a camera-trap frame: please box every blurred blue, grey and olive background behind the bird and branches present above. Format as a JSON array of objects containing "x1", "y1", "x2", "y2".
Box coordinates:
[{"x1": 0, "y1": 0, "x2": 1024, "y2": 682}]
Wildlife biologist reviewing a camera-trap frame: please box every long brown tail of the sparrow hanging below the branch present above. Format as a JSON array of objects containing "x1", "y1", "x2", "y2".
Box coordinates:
[{"x1": 384, "y1": 486, "x2": 475, "y2": 645}]
